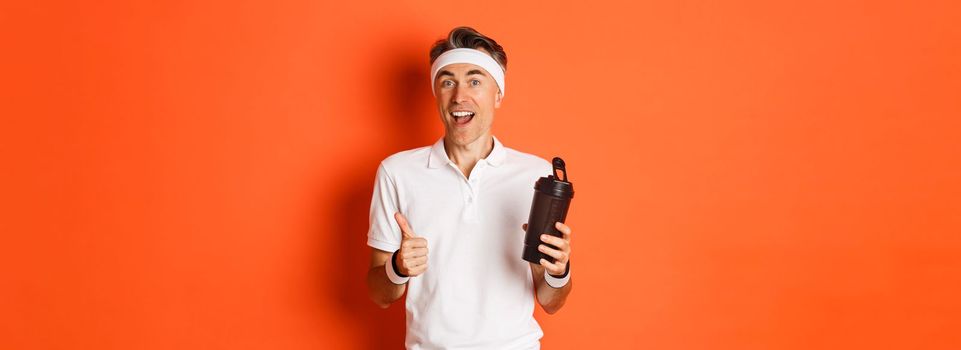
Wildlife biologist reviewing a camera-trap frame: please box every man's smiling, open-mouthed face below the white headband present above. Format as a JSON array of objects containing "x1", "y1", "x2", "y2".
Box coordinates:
[{"x1": 434, "y1": 57, "x2": 501, "y2": 146}]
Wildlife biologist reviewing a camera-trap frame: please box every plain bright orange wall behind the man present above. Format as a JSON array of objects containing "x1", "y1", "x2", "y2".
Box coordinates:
[{"x1": 0, "y1": 0, "x2": 961, "y2": 349}]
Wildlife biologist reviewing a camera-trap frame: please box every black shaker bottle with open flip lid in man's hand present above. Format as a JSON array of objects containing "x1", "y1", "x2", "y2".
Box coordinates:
[{"x1": 523, "y1": 157, "x2": 574, "y2": 264}]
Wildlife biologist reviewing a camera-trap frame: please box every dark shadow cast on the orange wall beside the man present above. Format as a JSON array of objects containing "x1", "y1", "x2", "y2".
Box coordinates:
[{"x1": 315, "y1": 41, "x2": 440, "y2": 349}]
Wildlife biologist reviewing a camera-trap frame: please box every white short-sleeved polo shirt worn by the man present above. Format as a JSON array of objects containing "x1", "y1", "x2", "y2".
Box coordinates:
[{"x1": 367, "y1": 138, "x2": 552, "y2": 349}]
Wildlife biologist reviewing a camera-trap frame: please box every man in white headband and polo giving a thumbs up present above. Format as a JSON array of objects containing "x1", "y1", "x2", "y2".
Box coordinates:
[{"x1": 367, "y1": 27, "x2": 572, "y2": 349}]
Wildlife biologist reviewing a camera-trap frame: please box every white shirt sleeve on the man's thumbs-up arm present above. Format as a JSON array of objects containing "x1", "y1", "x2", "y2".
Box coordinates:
[{"x1": 367, "y1": 163, "x2": 401, "y2": 252}]
